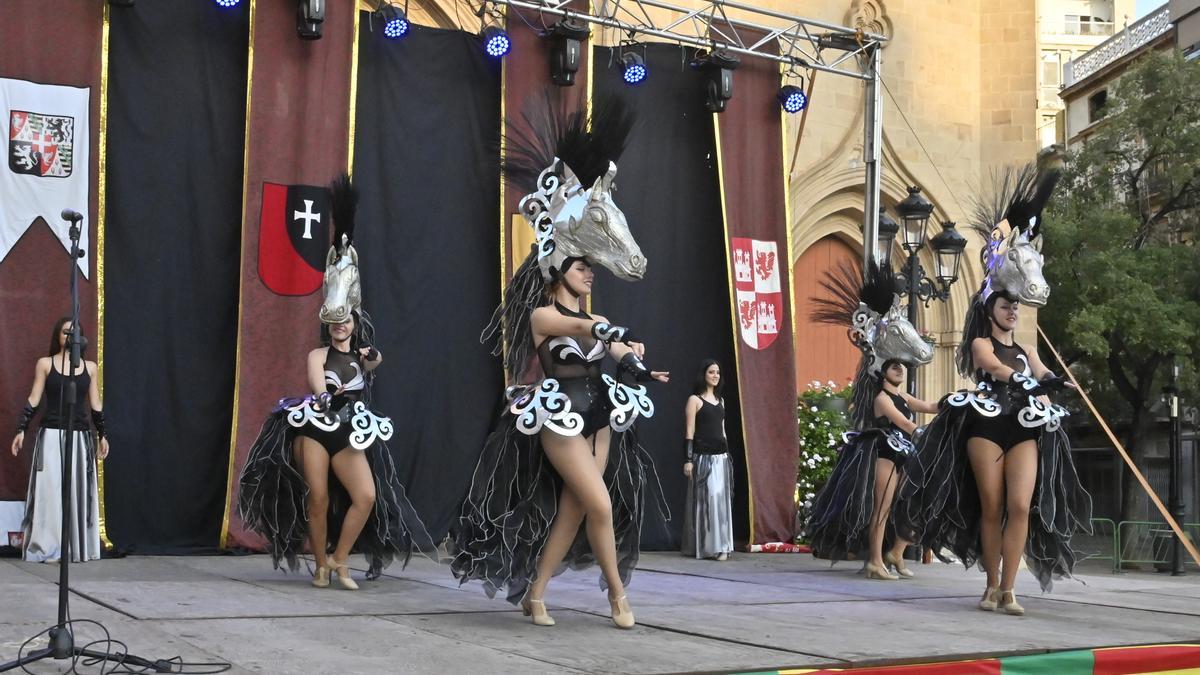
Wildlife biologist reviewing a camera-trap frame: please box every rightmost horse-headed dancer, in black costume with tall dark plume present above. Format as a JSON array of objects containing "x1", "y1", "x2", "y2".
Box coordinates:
[{"x1": 896, "y1": 167, "x2": 1092, "y2": 615}]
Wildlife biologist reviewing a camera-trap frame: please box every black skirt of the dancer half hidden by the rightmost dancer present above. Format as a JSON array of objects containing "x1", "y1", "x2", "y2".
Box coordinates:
[{"x1": 805, "y1": 429, "x2": 912, "y2": 561}]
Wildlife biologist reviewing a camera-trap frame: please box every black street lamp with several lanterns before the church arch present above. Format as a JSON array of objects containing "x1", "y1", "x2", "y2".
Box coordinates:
[{"x1": 880, "y1": 186, "x2": 967, "y2": 396}]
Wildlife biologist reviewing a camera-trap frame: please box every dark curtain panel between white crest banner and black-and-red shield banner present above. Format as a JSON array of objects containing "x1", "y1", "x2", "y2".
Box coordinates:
[{"x1": 104, "y1": 0, "x2": 250, "y2": 552}]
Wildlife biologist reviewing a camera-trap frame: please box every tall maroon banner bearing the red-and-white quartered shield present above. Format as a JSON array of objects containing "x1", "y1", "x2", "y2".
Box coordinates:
[{"x1": 714, "y1": 36, "x2": 799, "y2": 543}]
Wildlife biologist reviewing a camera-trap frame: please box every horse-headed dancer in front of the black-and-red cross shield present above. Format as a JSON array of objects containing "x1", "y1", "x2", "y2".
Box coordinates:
[{"x1": 238, "y1": 175, "x2": 437, "y2": 590}]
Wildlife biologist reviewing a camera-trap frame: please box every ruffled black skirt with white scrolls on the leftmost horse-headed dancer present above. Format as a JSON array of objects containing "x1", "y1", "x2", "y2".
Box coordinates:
[{"x1": 238, "y1": 399, "x2": 438, "y2": 579}]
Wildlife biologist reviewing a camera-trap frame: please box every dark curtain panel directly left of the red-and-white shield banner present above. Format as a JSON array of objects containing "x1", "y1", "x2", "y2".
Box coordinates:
[{"x1": 593, "y1": 44, "x2": 748, "y2": 550}]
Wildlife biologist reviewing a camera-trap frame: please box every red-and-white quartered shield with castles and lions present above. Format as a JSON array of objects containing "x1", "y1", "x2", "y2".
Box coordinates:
[{"x1": 731, "y1": 237, "x2": 785, "y2": 350}]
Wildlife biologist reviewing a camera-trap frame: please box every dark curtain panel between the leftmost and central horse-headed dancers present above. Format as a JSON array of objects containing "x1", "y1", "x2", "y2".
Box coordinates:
[{"x1": 354, "y1": 19, "x2": 504, "y2": 538}]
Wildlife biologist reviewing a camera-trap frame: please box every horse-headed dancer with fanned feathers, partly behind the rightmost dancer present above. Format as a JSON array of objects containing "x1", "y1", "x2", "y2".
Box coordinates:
[{"x1": 806, "y1": 264, "x2": 937, "y2": 580}]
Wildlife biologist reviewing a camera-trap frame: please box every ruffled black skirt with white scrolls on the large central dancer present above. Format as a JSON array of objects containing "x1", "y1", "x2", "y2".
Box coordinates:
[{"x1": 450, "y1": 380, "x2": 668, "y2": 604}]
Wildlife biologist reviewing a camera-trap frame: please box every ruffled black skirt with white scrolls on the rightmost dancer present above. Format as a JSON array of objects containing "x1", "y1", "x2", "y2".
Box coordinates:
[{"x1": 893, "y1": 392, "x2": 1092, "y2": 591}]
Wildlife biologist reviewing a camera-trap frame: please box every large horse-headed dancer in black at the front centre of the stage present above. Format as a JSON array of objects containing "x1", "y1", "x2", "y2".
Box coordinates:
[{"x1": 451, "y1": 97, "x2": 667, "y2": 628}]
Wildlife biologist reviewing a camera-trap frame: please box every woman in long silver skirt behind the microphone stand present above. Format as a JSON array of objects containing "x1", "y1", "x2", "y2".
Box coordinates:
[{"x1": 12, "y1": 318, "x2": 108, "y2": 562}]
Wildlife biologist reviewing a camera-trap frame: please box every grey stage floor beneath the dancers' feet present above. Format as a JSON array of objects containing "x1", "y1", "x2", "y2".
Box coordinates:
[{"x1": 0, "y1": 552, "x2": 1200, "y2": 674}]
